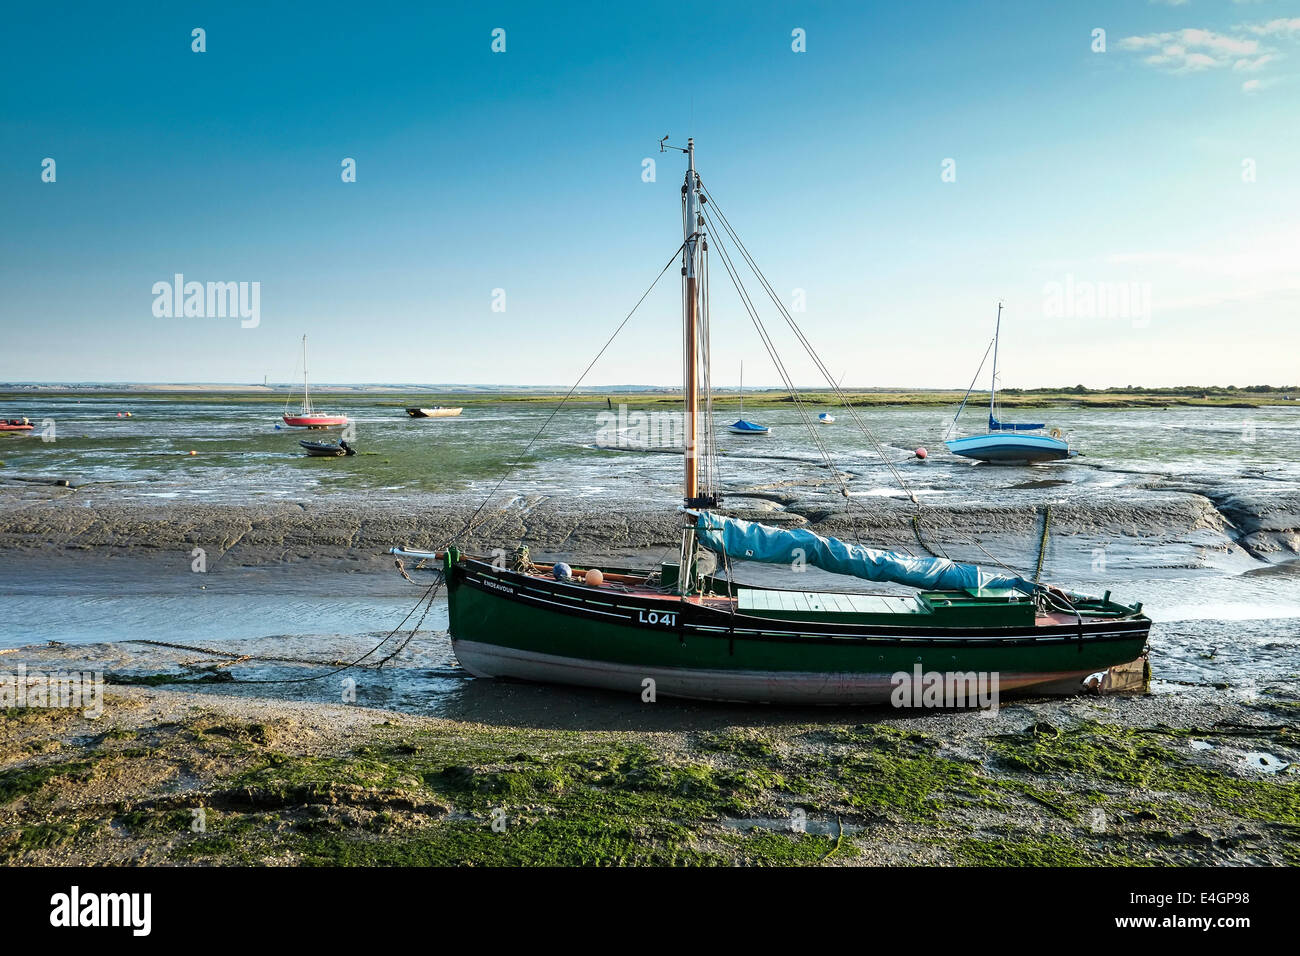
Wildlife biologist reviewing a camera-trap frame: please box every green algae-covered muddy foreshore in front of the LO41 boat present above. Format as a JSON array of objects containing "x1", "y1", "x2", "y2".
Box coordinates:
[{"x1": 0, "y1": 714, "x2": 1300, "y2": 866}]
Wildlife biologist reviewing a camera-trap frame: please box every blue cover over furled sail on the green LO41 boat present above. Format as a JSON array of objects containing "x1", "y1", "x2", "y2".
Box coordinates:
[{"x1": 692, "y1": 511, "x2": 1035, "y2": 593}]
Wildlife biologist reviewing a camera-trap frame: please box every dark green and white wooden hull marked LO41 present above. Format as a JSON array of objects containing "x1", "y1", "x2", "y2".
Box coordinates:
[{"x1": 447, "y1": 559, "x2": 1151, "y2": 705}]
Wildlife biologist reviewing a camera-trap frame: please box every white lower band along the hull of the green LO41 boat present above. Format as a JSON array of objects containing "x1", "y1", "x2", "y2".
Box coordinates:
[{"x1": 451, "y1": 640, "x2": 1095, "y2": 706}]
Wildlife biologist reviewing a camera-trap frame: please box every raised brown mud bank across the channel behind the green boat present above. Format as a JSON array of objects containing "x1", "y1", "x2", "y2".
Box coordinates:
[{"x1": 0, "y1": 486, "x2": 1300, "y2": 564}]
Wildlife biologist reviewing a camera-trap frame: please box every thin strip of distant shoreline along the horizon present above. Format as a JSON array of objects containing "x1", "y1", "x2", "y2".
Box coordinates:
[{"x1": 0, "y1": 384, "x2": 1300, "y2": 408}]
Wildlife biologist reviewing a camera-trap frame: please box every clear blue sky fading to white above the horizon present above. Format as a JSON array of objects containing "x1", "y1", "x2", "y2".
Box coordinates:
[{"x1": 0, "y1": 0, "x2": 1300, "y2": 386}]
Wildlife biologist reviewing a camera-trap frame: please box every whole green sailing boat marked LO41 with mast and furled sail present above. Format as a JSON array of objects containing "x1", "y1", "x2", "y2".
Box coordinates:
[{"x1": 393, "y1": 138, "x2": 1151, "y2": 705}]
